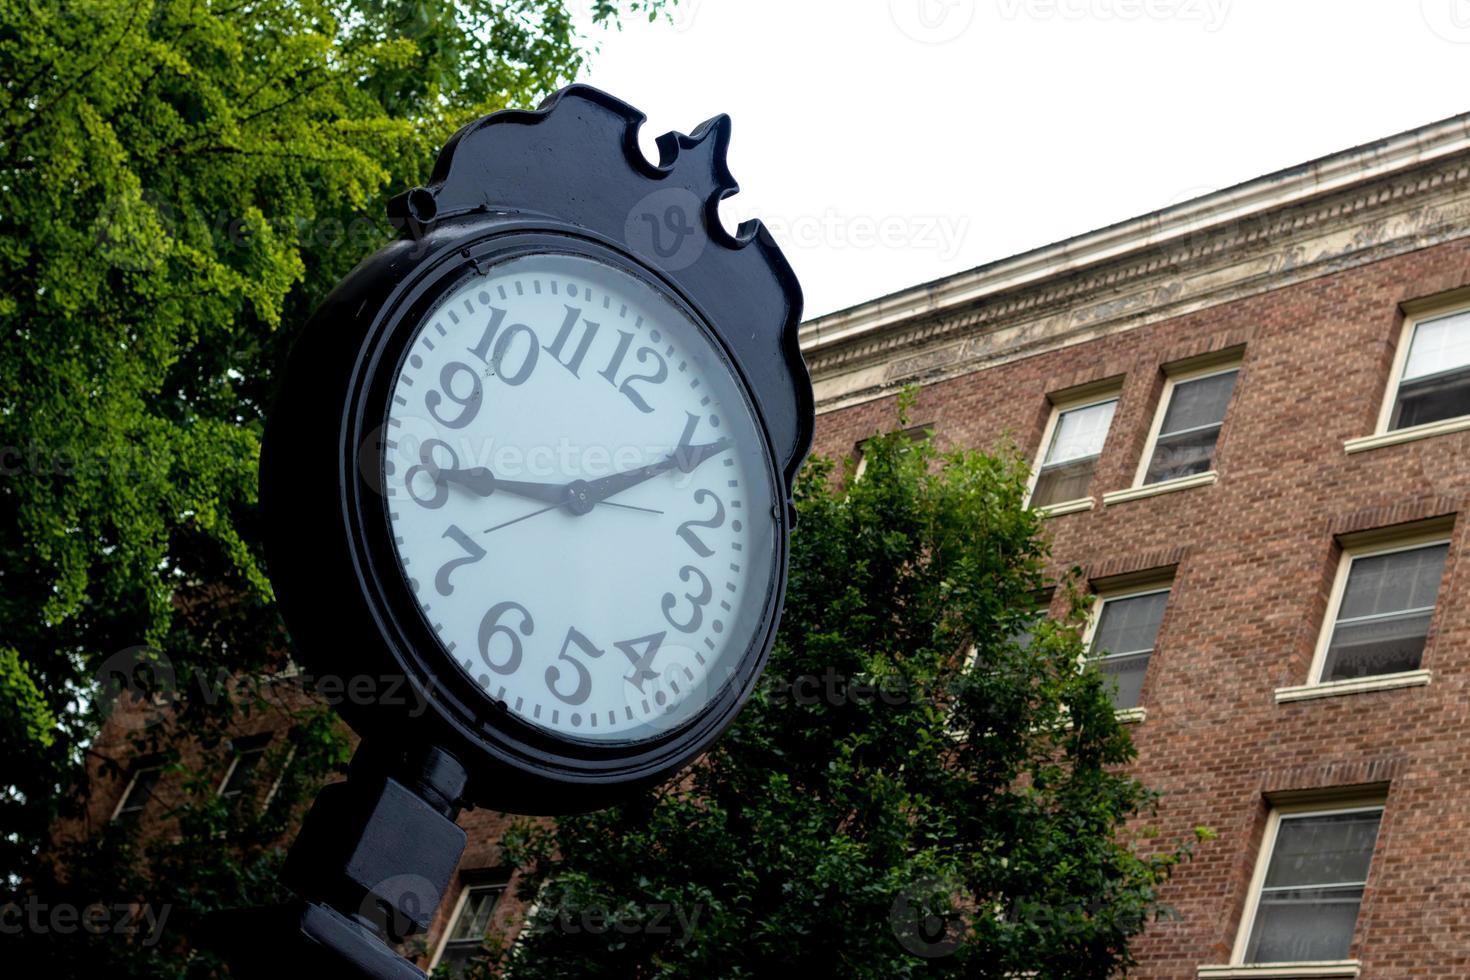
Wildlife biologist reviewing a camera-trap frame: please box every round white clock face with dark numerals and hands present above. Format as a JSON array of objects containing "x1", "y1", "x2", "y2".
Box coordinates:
[{"x1": 384, "y1": 253, "x2": 776, "y2": 742}]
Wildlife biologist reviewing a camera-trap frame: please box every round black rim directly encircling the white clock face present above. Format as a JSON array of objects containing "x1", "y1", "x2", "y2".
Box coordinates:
[{"x1": 344, "y1": 222, "x2": 789, "y2": 805}]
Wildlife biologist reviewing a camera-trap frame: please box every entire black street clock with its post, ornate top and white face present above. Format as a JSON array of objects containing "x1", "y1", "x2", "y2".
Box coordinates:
[{"x1": 221, "y1": 85, "x2": 813, "y2": 980}]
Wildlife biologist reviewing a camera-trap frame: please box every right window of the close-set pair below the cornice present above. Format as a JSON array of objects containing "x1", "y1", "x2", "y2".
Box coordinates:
[{"x1": 1135, "y1": 366, "x2": 1241, "y2": 486}]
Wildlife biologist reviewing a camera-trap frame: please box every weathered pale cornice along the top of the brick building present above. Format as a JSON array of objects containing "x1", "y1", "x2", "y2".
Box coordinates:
[{"x1": 801, "y1": 115, "x2": 1470, "y2": 411}]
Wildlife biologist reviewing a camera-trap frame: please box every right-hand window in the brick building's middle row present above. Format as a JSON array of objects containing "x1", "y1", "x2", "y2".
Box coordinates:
[{"x1": 1311, "y1": 536, "x2": 1449, "y2": 683}]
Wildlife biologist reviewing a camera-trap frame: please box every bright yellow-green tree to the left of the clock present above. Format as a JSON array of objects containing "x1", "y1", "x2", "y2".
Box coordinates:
[{"x1": 0, "y1": 0, "x2": 660, "y2": 973}]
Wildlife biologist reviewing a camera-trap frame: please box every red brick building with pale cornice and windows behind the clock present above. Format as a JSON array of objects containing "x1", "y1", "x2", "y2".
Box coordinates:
[{"x1": 83, "y1": 116, "x2": 1470, "y2": 979}]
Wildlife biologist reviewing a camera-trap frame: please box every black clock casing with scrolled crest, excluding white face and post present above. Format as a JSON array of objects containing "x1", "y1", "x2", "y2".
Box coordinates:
[{"x1": 260, "y1": 85, "x2": 813, "y2": 814}]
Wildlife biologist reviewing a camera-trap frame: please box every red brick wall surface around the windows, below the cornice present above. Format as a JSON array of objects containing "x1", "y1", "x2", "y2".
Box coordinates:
[{"x1": 817, "y1": 242, "x2": 1470, "y2": 979}]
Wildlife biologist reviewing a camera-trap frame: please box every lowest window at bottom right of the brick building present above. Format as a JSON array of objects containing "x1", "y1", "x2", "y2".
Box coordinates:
[{"x1": 1236, "y1": 805, "x2": 1383, "y2": 964}]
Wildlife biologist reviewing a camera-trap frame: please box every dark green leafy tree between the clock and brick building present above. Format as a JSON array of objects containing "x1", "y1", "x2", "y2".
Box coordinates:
[{"x1": 490, "y1": 405, "x2": 1204, "y2": 980}]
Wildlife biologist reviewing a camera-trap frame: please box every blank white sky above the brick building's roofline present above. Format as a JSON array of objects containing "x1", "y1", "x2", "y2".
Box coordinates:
[{"x1": 581, "y1": 0, "x2": 1470, "y2": 316}]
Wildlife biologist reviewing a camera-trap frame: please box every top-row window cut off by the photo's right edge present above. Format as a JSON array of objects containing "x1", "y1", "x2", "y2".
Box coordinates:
[{"x1": 1382, "y1": 310, "x2": 1470, "y2": 430}]
